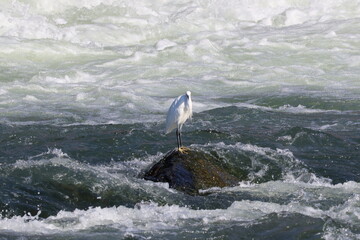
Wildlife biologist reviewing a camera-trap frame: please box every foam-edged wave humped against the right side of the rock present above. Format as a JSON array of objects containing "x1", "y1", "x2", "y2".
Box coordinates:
[{"x1": 191, "y1": 142, "x2": 331, "y2": 185}]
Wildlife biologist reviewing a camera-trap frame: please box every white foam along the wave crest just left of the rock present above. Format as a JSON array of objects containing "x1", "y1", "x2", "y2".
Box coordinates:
[{"x1": 3, "y1": 148, "x2": 173, "y2": 199}]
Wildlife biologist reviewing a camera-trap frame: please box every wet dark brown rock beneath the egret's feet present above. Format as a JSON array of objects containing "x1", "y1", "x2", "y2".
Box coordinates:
[{"x1": 144, "y1": 148, "x2": 245, "y2": 195}]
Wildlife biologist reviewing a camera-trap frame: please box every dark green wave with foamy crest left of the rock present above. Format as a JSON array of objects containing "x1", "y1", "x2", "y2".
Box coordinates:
[{"x1": 0, "y1": 148, "x2": 176, "y2": 217}]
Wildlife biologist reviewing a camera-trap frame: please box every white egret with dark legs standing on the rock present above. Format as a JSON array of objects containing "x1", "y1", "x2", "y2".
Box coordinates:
[{"x1": 165, "y1": 91, "x2": 192, "y2": 151}]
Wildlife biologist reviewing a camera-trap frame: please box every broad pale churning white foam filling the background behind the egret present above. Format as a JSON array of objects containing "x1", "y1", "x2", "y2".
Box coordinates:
[{"x1": 0, "y1": 0, "x2": 360, "y2": 124}]
